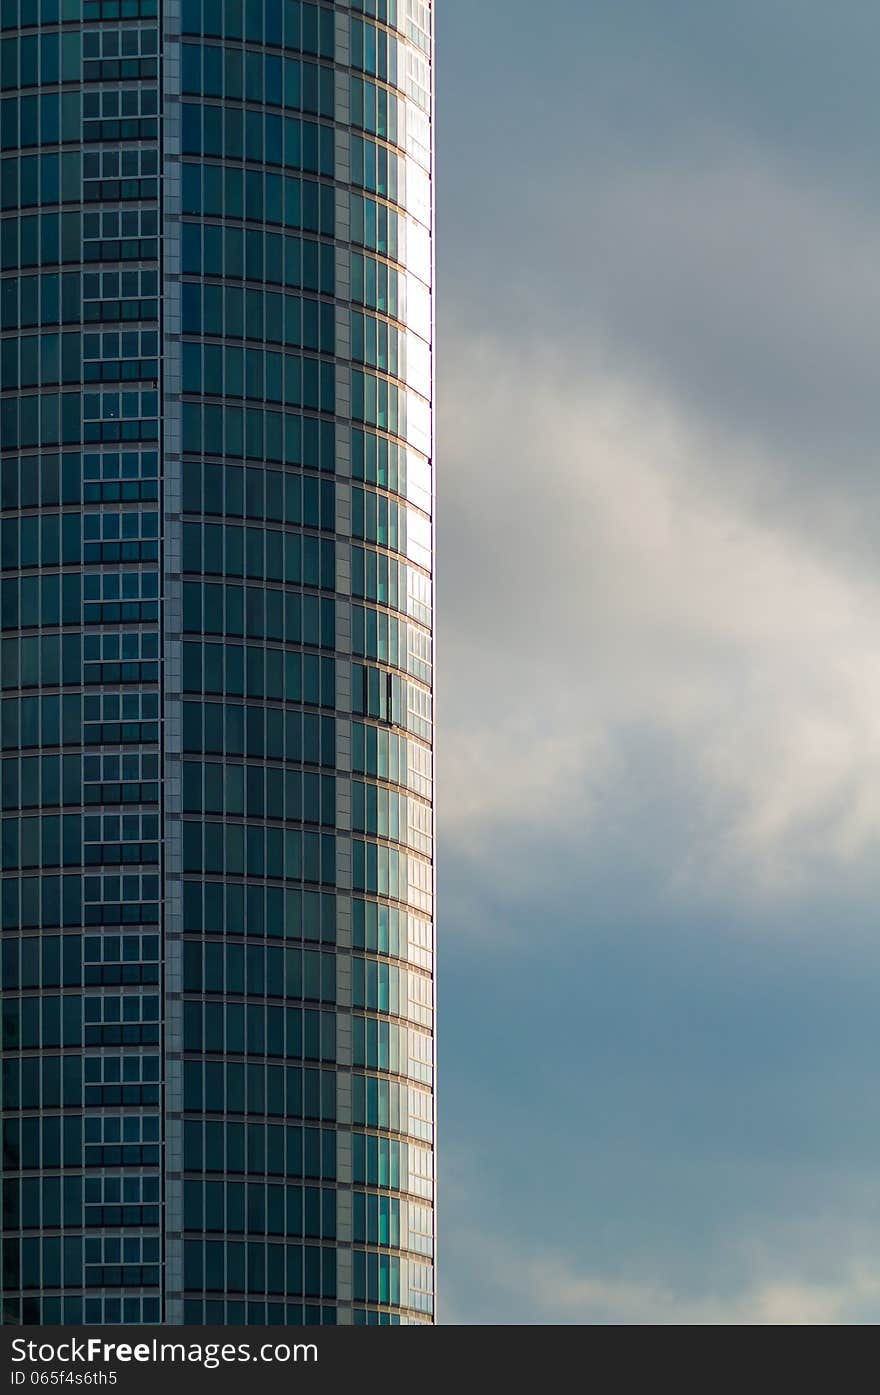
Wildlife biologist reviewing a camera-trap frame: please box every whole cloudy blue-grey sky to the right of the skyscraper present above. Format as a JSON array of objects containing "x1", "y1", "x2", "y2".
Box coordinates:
[{"x1": 435, "y1": 0, "x2": 880, "y2": 1324}]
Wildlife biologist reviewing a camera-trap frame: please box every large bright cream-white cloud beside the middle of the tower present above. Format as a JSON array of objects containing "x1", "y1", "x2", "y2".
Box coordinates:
[{"x1": 439, "y1": 326, "x2": 880, "y2": 891}]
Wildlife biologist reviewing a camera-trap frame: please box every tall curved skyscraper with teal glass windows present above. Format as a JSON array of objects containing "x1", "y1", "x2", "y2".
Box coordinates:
[{"x1": 0, "y1": 0, "x2": 434, "y2": 1324}]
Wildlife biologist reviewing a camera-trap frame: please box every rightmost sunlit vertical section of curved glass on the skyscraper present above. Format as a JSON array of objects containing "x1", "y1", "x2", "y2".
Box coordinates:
[{"x1": 337, "y1": 0, "x2": 434, "y2": 1324}]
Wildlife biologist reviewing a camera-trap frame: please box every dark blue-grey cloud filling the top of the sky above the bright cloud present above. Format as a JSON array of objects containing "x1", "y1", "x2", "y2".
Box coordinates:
[{"x1": 441, "y1": 0, "x2": 880, "y2": 550}]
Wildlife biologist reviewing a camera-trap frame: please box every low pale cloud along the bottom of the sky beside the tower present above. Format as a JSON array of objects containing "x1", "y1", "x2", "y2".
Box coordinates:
[{"x1": 439, "y1": 1143, "x2": 880, "y2": 1327}]
